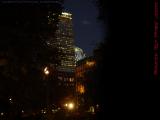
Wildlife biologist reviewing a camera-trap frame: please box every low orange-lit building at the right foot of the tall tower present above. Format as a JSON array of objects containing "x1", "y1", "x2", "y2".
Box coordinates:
[{"x1": 75, "y1": 57, "x2": 96, "y2": 109}]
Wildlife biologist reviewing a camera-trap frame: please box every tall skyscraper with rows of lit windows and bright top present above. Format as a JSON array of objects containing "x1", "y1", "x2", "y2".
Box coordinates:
[{"x1": 47, "y1": 12, "x2": 75, "y2": 72}]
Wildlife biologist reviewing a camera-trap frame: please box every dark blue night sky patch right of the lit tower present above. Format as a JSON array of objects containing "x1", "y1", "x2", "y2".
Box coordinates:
[{"x1": 64, "y1": 0, "x2": 103, "y2": 55}]
